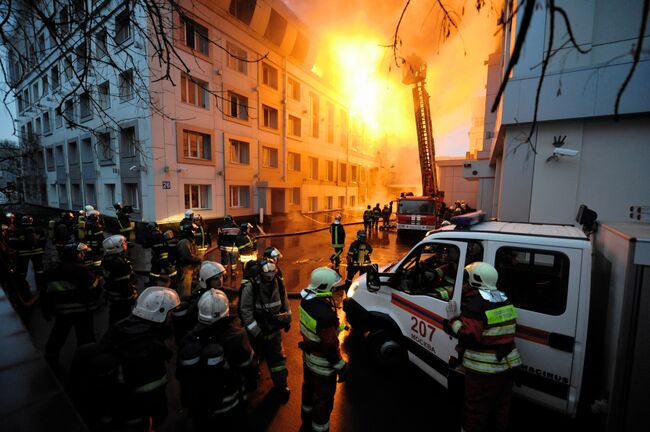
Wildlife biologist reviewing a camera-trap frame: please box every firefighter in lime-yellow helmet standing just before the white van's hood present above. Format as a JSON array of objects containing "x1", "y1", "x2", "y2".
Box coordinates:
[{"x1": 298, "y1": 267, "x2": 347, "y2": 431}]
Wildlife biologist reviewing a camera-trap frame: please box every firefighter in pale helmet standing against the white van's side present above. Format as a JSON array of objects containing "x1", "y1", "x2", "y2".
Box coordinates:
[{"x1": 443, "y1": 261, "x2": 521, "y2": 432}]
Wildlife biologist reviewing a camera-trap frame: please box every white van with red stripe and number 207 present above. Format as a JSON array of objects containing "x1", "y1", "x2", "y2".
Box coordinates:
[{"x1": 344, "y1": 212, "x2": 591, "y2": 416}]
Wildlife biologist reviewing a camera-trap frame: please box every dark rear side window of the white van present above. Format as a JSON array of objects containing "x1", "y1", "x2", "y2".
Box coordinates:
[{"x1": 494, "y1": 246, "x2": 569, "y2": 315}]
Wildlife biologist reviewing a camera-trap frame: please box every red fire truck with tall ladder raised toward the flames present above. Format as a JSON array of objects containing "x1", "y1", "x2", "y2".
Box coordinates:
[{"x1": 397, "y1": 56, "x2": 443, "y2": 232}]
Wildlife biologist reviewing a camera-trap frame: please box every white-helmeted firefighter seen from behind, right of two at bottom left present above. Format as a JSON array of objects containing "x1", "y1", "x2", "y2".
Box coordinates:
[{"x1": 176, "y1": 286, "x2": 258, "y2": 432}]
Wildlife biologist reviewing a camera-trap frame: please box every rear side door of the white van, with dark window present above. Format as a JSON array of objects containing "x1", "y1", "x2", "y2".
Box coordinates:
[{"x1": 488, "y1": 242, "x2": 582, "y2": 414}]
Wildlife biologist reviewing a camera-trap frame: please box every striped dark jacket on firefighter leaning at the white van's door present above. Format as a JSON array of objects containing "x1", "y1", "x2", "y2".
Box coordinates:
[{"x1": 443, "y1": 295, "x2": 521, "y2": 374}]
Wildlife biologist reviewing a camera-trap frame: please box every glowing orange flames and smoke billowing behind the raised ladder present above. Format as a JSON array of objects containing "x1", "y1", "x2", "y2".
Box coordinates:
[{"x1": 284, "y1": 0, "x2": 502, "y2": 191}]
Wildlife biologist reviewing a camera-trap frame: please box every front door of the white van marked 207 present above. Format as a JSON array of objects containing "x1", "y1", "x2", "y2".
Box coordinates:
[{"x1": 390, "y1": 240, "x2": 466, "y2": 386}]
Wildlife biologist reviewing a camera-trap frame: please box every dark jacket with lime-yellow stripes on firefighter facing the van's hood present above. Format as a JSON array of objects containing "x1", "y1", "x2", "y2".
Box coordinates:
[{"x1": 299, "y1": 289, "x2": 345, "y2": 376}]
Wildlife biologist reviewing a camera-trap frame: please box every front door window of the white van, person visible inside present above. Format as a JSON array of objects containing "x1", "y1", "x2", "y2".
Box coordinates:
[{"x1": 398, "y1": 243, "x2": 460, "y2": 302}]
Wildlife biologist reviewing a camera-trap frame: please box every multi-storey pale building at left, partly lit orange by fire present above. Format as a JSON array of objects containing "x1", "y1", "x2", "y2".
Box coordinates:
[{"x1": 9, "y1": 0, "x2": 377, "y2": 222}]
